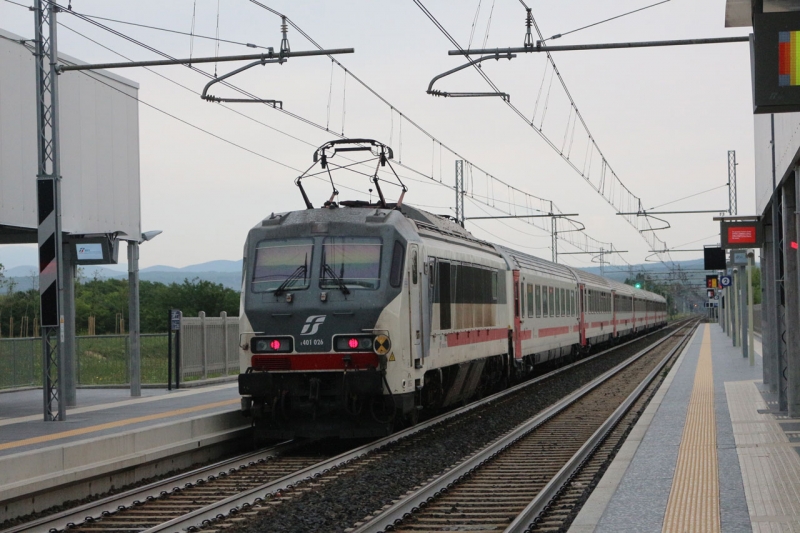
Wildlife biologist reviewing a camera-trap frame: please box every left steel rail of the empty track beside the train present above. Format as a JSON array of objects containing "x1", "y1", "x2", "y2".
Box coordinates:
[{"x1": 351, "y1": 320, "x2": 692, "y2": 533}]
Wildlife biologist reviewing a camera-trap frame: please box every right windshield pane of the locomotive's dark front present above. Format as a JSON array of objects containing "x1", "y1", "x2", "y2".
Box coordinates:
[{"x1": 319, "y1": 237, "x2": 383, "y2": 291}]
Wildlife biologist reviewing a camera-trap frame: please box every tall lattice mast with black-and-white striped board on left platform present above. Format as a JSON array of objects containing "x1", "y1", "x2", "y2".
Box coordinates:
[{"x1": 34, "y1": 0, "x2": 66, "y2": 421}]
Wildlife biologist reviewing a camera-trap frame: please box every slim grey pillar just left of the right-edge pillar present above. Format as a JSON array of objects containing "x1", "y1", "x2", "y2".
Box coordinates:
[{"x1": 761, "y1": 222, "x2": 778, "y2": 393}]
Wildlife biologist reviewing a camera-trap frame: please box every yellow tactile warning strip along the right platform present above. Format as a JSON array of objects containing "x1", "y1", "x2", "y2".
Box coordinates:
[{"x1": 662, "y1": 324, "x2": 720, "y2": 533}]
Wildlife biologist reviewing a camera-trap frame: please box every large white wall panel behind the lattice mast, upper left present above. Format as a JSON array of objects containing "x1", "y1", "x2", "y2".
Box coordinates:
[{"x1": 0, "y1": 30, "x2": 141, "y2": 236}]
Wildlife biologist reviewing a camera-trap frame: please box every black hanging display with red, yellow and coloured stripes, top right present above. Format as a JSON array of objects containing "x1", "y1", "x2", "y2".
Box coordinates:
[{"x1": 750, "y1": 11, "x2": 800, "y2": 113}]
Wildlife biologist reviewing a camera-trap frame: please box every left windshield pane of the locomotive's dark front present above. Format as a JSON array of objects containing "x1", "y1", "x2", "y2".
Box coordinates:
[{"x1": 253, "y1": 239, "x2": 314, "y2": 292}]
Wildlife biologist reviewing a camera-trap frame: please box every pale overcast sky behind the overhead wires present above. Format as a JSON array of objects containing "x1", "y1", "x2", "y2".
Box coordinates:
[{"x1": 0, "y1": 0, "x2": 754, "y2": 267}]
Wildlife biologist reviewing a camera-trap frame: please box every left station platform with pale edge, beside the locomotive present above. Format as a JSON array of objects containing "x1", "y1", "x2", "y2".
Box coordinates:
[{"x1": 0, "y1": 382, "x2": 249, "y2": 522}]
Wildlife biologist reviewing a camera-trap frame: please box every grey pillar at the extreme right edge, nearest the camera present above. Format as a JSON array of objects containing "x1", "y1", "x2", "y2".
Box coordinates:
[{"x1": 781, "y1": 176, "x2": 800, "y2": 417}]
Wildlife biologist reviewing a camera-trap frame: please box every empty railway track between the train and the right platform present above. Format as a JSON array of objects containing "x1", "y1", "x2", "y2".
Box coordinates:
[{"x1": 351, "y1": 323, "x2": 696, "y2": 533}]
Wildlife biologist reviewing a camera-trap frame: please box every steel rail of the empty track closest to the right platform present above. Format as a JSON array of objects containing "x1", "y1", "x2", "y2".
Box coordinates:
[{"x1": 504, "y1": 318, "x2": 697, "y2": 533}]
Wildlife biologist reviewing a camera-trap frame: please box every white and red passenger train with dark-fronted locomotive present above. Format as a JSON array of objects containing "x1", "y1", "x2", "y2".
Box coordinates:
[{"x1": 238, "y1": 139, "x2": 667, "y2": 439}]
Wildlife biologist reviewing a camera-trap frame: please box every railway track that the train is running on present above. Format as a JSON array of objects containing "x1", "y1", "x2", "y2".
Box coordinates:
[{"x1": 1, "y1": 320, "x2": 688, "y2": 533}]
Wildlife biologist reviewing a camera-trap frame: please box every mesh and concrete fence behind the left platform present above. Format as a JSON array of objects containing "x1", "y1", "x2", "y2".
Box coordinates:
[{"x1": 0, "y1": 313, "x2": 239, "y2": 389}]
